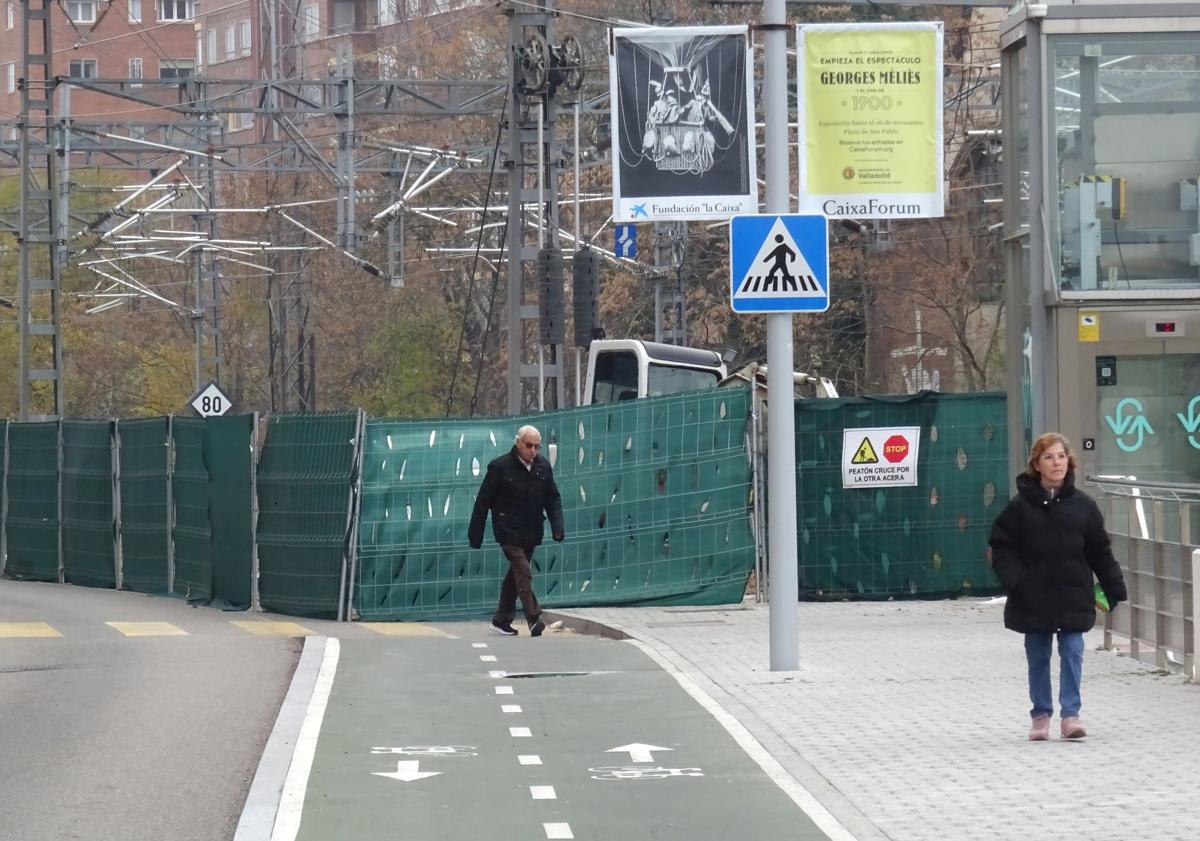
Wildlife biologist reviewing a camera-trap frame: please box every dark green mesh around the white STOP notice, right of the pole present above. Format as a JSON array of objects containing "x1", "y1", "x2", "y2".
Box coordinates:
[{"x1": 796, "y1": 392, "x2": 1008, "y2": 599}]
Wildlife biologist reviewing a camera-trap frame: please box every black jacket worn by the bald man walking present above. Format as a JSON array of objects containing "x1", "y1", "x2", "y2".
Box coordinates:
[{"x1": 467, "y1": 446, "x2": 563, "y2": 549}]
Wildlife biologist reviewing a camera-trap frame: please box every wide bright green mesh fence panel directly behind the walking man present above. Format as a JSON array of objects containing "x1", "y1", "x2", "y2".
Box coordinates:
[{"x1": 354, "y1": 389, "x2": 754, "y2": 620}]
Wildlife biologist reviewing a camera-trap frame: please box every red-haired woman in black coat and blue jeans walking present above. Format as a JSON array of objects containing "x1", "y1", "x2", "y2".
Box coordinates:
[{"x1": 988, "y1": 432, "x2": 1129, "y2": 741}]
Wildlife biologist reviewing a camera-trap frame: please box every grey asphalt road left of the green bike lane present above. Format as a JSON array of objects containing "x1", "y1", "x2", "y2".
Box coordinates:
[{"x1": 0, "y1": 579, "x2": 302, "y2": 841}]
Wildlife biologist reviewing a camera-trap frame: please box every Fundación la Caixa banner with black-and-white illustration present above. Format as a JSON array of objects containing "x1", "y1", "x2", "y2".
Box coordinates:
[{"x1": 608, "y1": 26, "x2": 758, "y2": 223}]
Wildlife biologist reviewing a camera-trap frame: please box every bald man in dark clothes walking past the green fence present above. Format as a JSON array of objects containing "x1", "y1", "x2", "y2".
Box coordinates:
[{"x1": 467, "y1": 426, "x2": 564, "y2": 637}]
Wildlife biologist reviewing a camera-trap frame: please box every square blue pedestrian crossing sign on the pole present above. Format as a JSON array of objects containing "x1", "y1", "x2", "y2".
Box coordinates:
[{"x1": 730, "y1": 214, "x2": 829, "y2": 313}]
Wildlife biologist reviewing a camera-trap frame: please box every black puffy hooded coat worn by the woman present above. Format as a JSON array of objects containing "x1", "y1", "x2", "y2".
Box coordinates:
[{"x1": 988, "y1": 470, "x2": 1129, "y2": 633}]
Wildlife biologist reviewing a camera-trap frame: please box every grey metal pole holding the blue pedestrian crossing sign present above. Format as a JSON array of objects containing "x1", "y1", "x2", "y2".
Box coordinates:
[{"x1": 762, "y1": 0, "x2": 800, "y2": 672}]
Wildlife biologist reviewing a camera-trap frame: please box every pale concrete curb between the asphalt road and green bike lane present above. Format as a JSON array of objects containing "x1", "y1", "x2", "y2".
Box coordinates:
[{"x1": 233, "y1": 636, "x2": 328, "y2": 841}]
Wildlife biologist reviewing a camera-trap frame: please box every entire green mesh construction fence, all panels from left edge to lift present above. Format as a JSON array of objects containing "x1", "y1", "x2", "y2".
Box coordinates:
[{"x1": 0, "y1": 389, "x2": 1008, "y2": 620}]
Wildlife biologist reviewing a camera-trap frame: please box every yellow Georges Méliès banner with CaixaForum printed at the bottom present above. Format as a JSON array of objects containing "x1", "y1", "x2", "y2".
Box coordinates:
[{"x1": 800, "y1": 24, "x2": 943, "y2": 218}]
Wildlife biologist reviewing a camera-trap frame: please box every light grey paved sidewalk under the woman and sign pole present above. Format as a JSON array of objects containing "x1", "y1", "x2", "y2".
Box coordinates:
[{"x1": 560, "y1": 600, "x2": 1200, "y2": 841}]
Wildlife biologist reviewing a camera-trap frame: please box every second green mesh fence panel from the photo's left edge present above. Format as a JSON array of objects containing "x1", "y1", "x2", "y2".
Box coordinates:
[{"x1": 62, "y1": 420, "x2": 116, "y2": 587}]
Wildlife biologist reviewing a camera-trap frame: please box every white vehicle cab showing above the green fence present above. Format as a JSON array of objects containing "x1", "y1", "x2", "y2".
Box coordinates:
[{"x1": 583, "y1": 338, "x2": 728, "y2": 406}]
